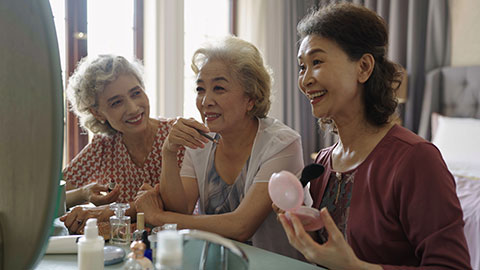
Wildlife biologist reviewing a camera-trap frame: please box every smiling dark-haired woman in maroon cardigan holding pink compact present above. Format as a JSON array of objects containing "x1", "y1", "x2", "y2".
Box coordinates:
[{"x1": 279, "y1": 4, "x2": 471, "y2": 269}]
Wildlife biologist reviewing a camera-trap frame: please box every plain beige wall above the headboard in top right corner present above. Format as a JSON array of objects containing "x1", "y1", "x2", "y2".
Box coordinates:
[{"x1": 450, "y1": 0, "x2": 480, "y2": 66}]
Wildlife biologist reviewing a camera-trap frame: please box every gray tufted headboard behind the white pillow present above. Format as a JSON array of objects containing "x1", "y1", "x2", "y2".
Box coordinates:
[{"x1": 419, "y1": 66, "x2": 480, "y2": 140}]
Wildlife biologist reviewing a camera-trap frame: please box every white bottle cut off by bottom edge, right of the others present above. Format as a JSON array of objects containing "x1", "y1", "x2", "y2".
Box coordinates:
[{"x1": 155, "y1": 230, "x2": 183, "y2": 270}]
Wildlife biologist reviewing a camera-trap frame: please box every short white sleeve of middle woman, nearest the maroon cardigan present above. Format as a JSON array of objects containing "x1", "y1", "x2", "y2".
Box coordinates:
[{"x1": 253, "y1": 139, "x2": 303, "y2": 183}]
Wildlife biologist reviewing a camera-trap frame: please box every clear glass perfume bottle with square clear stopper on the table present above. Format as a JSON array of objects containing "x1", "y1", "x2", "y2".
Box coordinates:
[{"x1": 110, "y1": 203, "x2": 130, "y2": 245}]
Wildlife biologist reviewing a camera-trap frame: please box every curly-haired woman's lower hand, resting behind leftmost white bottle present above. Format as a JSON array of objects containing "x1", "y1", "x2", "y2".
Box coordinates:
[{"x1": 60, "y1": 206, "x2": 113, "y2": 234}]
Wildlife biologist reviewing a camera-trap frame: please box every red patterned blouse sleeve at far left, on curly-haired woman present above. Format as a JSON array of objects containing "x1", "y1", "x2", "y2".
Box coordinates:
[{"x1": 63, "y1": 135, "x2": 104, "y2": 188}]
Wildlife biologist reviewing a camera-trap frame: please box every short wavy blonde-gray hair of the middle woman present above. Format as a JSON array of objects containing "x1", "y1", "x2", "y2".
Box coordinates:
[{"x1": 191, "y1": 36, "x2": 273, "y2": 118}]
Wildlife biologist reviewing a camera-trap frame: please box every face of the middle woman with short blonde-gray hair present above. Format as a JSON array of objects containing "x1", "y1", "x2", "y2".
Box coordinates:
[{"x1": 196, "y1": 61, "x2": 254, "y2": 133}]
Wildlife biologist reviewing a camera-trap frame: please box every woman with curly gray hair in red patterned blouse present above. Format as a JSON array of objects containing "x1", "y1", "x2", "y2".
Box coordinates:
[{"x1": 62, "y1": 55, "x2": 183, "y2": 232}]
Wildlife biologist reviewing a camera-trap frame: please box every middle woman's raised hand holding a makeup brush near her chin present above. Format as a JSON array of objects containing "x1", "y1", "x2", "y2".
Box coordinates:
[{"x1": 162, "y1": 117, "x2": 210, "y2": 154}]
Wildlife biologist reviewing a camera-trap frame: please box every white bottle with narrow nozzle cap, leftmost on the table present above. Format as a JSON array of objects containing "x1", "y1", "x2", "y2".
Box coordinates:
[{"x1": 77, "y1": 218, "x2": 105, "y2": 270}]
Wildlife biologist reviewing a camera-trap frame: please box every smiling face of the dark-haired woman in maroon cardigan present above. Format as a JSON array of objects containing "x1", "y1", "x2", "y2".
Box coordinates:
[{"x1": 298, "y1": 35, "x2": 362, "y2": 122}]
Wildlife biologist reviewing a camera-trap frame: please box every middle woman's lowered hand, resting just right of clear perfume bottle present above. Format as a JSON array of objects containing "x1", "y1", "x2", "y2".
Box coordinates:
[{"x1": 135, "y1": 184, "x2": 164, "y2": 226}]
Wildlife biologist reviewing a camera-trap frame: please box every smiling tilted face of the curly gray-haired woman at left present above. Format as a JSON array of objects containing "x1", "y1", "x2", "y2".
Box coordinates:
[{"x1": 94, "y1": 74, "x2": 150, "y2": 134}]
